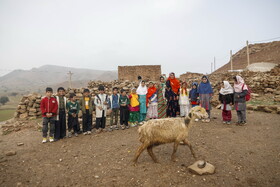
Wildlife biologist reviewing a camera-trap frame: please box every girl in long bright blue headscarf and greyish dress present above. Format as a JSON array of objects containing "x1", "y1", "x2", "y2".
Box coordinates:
[{"x1": 198, "y1": 75, "x2": 213, "y2": 122}]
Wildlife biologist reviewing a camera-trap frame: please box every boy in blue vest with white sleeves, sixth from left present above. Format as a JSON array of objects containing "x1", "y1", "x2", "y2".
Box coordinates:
[{"x1": 109, "y1": 87, "x2": 120, "y2": 131}]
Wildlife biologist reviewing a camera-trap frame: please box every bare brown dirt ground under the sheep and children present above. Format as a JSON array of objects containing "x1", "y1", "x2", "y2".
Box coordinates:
[{"x1": 0, "y1": 110, "x2": 280, "y2": 187}]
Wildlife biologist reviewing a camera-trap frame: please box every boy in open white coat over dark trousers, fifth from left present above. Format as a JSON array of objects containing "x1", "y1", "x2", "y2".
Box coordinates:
[{"x1": 94, "y1": 85, "x2": 108, "y2": 133}]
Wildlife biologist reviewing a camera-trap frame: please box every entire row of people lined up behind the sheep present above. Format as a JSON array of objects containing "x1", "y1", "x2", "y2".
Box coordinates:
[{"x1": 41, "y1": 73, "x2": 248, "y2": 143}]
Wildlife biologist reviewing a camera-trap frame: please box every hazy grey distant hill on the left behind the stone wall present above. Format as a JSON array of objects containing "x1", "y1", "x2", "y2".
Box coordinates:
[{"x1": 0, "y1": 65, "x2": 117, "y2": 92}]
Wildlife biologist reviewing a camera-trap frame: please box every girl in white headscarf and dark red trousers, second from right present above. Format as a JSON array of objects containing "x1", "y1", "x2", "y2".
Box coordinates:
[{"x1": 219, "y1": 81, "x2": 233, "y2": 125}]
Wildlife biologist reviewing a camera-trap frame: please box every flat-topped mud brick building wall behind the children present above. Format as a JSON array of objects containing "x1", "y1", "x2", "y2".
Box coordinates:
[{"x1": 118, "y1": 65, "x2": 161, "y2": 81}]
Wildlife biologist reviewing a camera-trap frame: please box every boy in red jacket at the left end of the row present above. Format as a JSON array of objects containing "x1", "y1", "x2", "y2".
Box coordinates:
[{"x1": 40, "y1": 87, "x2": 58, "y2": 143}]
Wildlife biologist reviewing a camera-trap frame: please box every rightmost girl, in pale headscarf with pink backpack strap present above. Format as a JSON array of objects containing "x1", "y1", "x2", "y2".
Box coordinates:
[{"x1": 233, "y1": 75, "x2": 248, "y2": 125}]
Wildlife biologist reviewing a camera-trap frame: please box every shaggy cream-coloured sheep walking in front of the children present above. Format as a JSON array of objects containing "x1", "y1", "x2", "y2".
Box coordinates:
[{"x1": 133, "y1": 106, "x2": 208, "y2": 165}]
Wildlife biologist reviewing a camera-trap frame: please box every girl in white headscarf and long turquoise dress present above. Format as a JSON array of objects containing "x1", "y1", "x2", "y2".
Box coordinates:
[{"x1": 136, "y1": 77, "x2": 148, "y2": 125}]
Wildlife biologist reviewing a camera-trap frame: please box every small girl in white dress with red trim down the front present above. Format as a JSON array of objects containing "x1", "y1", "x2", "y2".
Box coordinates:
[{"x1": 179, "y1": 82, "x2": 190, "y2": 117}]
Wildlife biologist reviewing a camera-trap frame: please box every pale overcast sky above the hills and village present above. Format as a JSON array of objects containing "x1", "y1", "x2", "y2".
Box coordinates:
[{"x1": 0, "y1": 0, "x2": 280, "y2": 75}]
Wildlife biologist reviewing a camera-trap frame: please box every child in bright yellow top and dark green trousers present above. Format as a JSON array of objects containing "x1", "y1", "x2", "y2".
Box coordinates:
[{"x1": 129, "y1": 88, "x2": 140, "y2": 127}]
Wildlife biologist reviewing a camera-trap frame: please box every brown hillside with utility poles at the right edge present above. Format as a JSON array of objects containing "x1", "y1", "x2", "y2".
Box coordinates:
[{"x1": 214, "y1": 41, "x2": 280, "y2": 73}]
